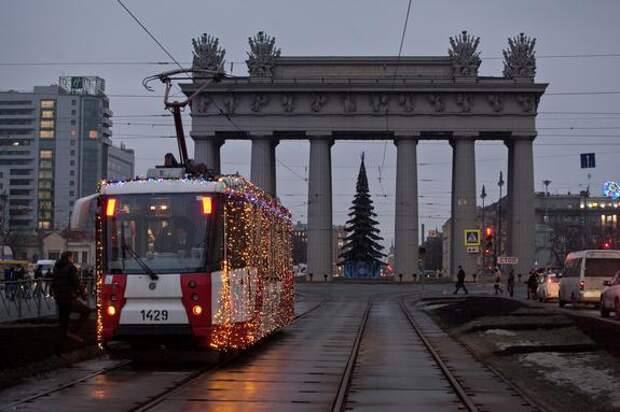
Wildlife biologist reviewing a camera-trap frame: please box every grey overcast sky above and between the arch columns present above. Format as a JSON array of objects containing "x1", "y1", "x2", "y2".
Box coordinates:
[{"x1": 0, "y1": 0, "x2": 620, "y2": 244}]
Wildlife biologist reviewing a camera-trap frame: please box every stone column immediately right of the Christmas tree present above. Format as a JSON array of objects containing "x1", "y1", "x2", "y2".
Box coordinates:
[{"x1": 394, "y1": 137, "x2": 419, "y2": 281}]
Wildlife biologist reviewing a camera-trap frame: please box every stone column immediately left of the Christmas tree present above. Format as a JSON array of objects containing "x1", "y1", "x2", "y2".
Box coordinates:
[{"x1": 307, "y1": 136, "x2": 333, "y2": 282}]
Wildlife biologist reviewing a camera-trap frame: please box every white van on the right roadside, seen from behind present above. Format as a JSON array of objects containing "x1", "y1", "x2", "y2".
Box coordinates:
[{"x1": 558, "y1": 250, "x2": 620, "y2": 307}]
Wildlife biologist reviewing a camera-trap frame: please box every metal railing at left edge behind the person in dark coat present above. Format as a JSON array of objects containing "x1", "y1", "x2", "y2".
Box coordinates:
[{"x1": 0, "y1": 277, "x2": 96, "y2": 323}]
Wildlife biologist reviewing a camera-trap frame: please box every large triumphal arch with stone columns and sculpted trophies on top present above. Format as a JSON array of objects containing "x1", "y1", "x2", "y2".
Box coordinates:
[{"x1": 182, "y1": 32, "x2": 547, "y2": 281}]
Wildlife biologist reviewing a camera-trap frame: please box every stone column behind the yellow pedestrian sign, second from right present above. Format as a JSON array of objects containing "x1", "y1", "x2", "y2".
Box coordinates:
[{"x1": 450, "y1": 136, "x2": 479, "y2": 278}]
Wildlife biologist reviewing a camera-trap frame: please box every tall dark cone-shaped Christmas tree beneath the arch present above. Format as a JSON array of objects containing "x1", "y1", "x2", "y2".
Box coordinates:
[{"x1": 339, "y1": 153, "x2": 385, "y2": 277}]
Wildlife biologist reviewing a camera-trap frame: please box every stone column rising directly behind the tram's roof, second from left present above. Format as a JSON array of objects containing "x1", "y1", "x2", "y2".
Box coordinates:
[{"x1": 250, "y1": 136, "x2": 278, "y2": 196}]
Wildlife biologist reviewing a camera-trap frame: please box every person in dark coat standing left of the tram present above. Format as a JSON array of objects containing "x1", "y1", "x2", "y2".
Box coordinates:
[{"x1": 51, "y1": 252, "x2": 90, "y2": 342}]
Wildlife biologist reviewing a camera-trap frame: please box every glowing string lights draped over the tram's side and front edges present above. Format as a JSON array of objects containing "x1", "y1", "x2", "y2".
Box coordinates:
[{"x1": 95, "y1": 175, "x2": 294, "y2": 350}]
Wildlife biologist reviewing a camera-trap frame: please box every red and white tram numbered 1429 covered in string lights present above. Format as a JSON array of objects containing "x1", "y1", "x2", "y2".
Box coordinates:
[{"x1": 72, "y1": 169, "x2": 294, "y2": 350}]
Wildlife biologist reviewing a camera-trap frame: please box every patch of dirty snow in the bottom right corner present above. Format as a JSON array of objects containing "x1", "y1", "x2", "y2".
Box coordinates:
[{"x1": 520, "y1": 352, "x2": 620, "y2": 406}]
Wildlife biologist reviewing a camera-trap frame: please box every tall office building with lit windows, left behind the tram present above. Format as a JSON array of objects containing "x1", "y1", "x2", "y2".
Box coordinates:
[{"x1": 0, "y1": 76, "x2": 134, "y2": 232}]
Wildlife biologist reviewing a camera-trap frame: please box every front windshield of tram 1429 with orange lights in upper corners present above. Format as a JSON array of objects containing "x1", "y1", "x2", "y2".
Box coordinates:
[{"x1": 102, "y1": 193, "x2": 222, "y2": 274}]
